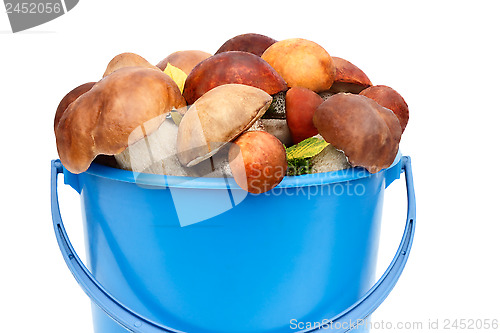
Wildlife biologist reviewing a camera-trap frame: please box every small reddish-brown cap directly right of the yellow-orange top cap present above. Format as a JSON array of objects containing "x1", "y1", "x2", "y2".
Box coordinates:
[{"x1": 329, "y1": 57, "x2": 372, "y2": 94}]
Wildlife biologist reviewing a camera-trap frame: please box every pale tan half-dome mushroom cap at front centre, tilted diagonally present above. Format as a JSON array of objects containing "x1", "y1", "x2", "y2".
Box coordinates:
[{"x1": 177, "y1": 84, "x2": 272, "y2": 167}]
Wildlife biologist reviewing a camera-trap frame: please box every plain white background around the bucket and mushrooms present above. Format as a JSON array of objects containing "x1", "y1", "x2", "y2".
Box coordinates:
[{"x1": 0, "y1": 0, "x2": 500, "y2": 333}]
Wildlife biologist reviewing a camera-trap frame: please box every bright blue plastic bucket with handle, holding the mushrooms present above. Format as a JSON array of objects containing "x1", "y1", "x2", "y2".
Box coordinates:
[{"x1": 52, "y1": 155, "x2": 415, "y2": 333}]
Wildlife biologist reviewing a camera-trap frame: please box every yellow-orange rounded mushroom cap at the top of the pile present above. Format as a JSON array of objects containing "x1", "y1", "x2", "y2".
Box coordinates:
[{"x1": 262, "y1": 38, "x2": 335, "y2": 92}]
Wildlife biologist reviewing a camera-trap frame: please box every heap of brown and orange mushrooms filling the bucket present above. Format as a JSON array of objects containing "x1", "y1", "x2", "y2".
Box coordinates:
[{"x1": 54, "y1": 34, "x2": 409, "y2": 193}]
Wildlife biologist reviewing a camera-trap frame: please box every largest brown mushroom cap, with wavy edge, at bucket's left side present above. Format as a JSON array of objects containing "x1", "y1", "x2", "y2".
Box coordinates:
[{"x1": 56, "y1": 67, "x2": 186, "y2": 173}]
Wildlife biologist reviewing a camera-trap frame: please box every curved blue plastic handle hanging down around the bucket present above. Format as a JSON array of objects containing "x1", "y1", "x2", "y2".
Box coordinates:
[{"x1": 51, "y1": 156, "x2": 416, "y2": 333}]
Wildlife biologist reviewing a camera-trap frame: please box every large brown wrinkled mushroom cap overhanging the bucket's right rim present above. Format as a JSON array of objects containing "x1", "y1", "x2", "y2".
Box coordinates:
[{"x1": 313, "y1": 93, "x2": 401, "y2": 173}]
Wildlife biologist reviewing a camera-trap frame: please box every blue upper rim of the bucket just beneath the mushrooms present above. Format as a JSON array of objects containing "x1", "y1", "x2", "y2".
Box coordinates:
[{"x1": 84, "y1": 151, "x2": 402, "y2": 190}]
